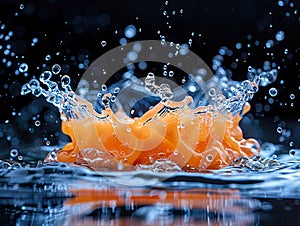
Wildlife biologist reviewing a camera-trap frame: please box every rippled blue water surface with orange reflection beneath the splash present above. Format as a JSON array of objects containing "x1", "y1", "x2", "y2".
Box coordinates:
[{"x1": 0, "y1": 148, "x2": 300, "y2": 225}]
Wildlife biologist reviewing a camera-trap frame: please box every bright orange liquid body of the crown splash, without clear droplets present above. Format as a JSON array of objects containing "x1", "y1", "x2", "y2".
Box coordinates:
[{"x1": 57, "y1": 97, "x2": 260, "y2": 170}]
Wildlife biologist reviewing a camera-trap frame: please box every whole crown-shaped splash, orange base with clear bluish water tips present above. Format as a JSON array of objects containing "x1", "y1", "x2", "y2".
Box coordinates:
[{"x1": 21, "y1": 53, "x2": 277, "y2": 171}]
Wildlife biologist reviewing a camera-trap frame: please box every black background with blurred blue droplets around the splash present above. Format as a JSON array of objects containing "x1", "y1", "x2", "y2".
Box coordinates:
[{"x1": 0, "y1": 0, "x2": 300, "y2": 154}]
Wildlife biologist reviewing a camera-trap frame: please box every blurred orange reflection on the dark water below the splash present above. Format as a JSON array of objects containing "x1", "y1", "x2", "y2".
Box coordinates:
[{"x1": 66, "y1": 187, "x2": 260, "y2": 225}]
